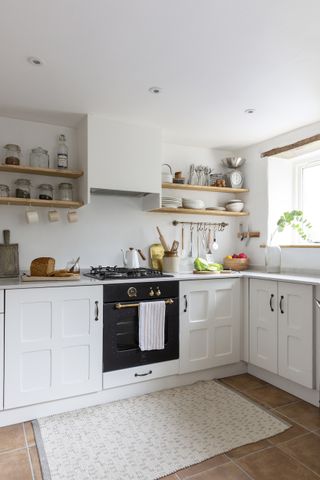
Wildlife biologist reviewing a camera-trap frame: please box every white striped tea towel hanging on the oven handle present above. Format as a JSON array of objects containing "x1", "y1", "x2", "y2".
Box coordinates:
[{"x1": 139, "y1": 301, "x2": 166, "y2": 350}]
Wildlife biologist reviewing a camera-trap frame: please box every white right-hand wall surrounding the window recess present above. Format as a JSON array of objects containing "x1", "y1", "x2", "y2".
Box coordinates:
[{"x1": 238, "y1": 118, "x2": 320, "y2": 270}]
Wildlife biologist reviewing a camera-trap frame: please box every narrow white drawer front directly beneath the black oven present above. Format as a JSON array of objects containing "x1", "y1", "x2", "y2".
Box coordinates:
[{"x1": 103, "y1": 360, "x2": 179, "y2": 389}]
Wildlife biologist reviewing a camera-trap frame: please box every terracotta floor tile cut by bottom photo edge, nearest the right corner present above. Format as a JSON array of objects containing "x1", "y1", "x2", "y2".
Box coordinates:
[{"x1": 237, "y1": 447, "x2": 319, "y2": 480}]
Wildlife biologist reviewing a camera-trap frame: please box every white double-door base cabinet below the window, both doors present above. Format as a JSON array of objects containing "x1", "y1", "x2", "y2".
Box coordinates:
[{"x1": 250, "y1": 279, "x2": 314, "y2": 388}]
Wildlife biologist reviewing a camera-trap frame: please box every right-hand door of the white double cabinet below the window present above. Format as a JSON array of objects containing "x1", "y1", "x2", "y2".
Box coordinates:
[{"x1": 278, "y1": 282, "x2": 314, "y2": 388}]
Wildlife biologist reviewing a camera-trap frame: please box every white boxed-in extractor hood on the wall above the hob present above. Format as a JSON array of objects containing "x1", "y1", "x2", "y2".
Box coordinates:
[{"x1": 79, "y1": 115, "x2": 162, "y2": 194}]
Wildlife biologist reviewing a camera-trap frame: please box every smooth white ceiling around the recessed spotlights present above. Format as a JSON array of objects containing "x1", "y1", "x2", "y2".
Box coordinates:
[{"x1": 0, "y1": 0, "x2": 320, "y2": 148}]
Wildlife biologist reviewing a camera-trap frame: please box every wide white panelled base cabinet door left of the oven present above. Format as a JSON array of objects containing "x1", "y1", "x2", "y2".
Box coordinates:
[{"x1": 4, "y1": 286, "x2": 103, "y2": 409}]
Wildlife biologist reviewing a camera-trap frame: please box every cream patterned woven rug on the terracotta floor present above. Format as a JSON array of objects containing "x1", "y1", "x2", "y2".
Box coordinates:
[{"x1": 34, "y1": 381, "x2": 289, "y2": 480}]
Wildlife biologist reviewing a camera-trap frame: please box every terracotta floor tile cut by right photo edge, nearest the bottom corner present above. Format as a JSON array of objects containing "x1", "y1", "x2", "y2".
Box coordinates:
[{"x1": 279, "y1": 433, "x2": 320, "y2": 475}]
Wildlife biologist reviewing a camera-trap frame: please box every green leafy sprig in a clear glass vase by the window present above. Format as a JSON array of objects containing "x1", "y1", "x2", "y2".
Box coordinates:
[{"x1": 265, "y1": 210, "x2": 312, "y2": 273}]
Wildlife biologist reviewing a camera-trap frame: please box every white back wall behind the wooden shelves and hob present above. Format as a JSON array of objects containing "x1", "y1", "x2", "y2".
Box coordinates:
[{"x1": 0, "y1": 118, "x2": 240, "y2": 269}]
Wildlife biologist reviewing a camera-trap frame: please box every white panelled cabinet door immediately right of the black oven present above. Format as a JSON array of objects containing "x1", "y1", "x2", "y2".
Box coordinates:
[{"x1": 180, "y1": 279, "x2": 240, "y2": 373}]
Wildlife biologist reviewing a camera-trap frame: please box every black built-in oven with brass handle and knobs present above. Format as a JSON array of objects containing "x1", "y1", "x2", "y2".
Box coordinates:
[{"x1": 103, "y1": 281, "x2": 179, "y2": 372}]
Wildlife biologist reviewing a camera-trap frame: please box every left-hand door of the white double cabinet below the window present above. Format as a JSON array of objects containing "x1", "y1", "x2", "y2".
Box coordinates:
[{"x1": 249, "y1": 279, "x2": 278, "y2": 373}]
